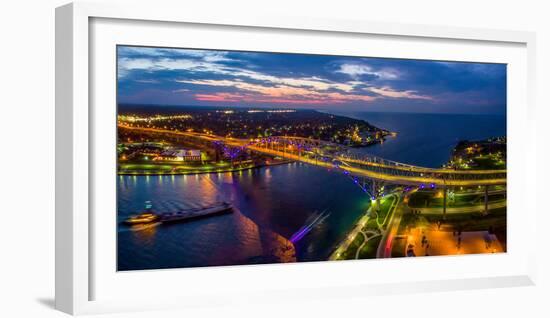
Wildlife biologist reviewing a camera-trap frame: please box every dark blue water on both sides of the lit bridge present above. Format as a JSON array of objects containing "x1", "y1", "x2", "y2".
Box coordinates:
[{"x1": 117, "y1": 113, "x2": 506, "y2": 270}]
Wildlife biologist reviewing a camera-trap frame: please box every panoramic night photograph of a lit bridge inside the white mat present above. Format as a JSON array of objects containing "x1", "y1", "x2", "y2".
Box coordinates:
[{"x1": 116, "y1": 45, "x2": 507, "y2": 271}]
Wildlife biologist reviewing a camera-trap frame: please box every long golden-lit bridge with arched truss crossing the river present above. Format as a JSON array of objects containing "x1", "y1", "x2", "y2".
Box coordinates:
[{"x1": 119, "y1": 125, "x2": 506, "y2": 186}]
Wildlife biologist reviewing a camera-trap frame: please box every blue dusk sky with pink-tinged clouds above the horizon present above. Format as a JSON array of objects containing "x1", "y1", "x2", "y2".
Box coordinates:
[{"x1": 118, "y1": 46, "x2": 506, "y2": 114}]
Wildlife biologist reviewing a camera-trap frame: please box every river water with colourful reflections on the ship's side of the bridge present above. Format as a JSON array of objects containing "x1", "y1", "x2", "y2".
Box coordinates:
[{"x1": 117, "y1": 163, "x2": 374, "y2": 270}]
